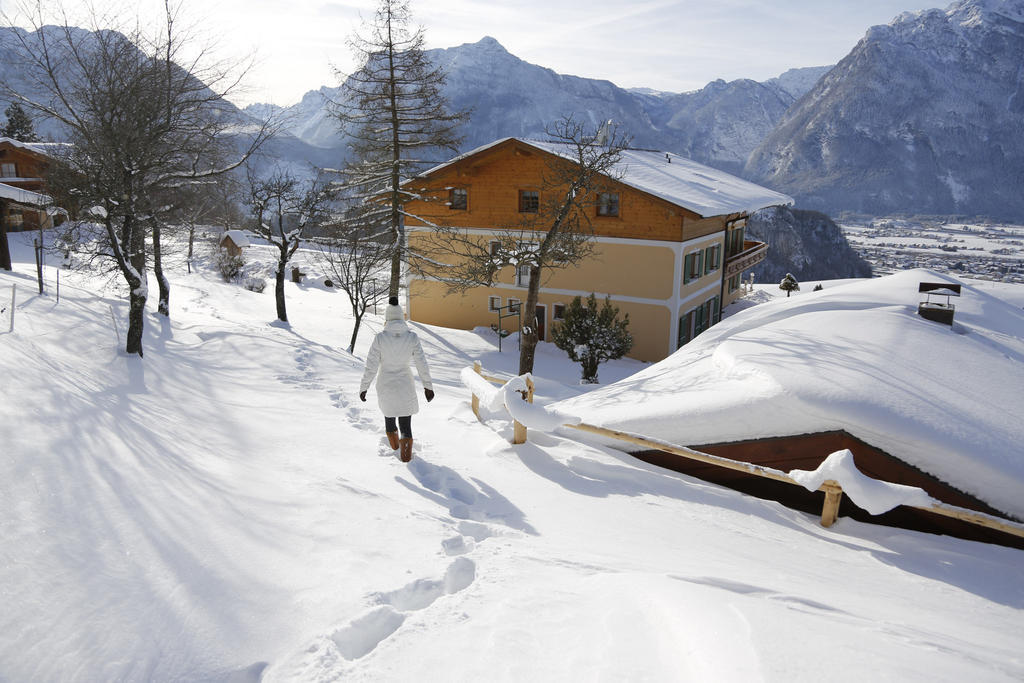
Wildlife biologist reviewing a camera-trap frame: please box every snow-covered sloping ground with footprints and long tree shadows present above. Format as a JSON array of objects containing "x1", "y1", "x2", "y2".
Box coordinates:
[{"x1": 6, "y1": 231, "x2": 1024, "y2": 681}]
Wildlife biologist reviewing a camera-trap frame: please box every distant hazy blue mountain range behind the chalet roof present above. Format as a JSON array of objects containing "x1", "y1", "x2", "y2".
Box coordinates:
[{"x1": 247, "y1": 37, "x2": 828, "y2": 171}]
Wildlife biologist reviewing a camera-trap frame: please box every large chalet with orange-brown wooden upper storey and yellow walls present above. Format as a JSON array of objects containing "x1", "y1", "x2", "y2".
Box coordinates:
[{"x1": 406, "y1": 138, "x2": 793, "y2": 361}]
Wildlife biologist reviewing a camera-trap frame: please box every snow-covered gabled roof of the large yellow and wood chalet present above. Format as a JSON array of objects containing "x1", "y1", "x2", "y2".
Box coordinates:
[{"x1": 415, "y1": 137, "x2": 794, "y2": 222}]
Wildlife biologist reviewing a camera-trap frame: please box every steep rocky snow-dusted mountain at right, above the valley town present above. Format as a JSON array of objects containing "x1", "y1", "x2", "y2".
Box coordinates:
[{"x1": 746, "y1": 0, "x2": 1024, "y2": 219}]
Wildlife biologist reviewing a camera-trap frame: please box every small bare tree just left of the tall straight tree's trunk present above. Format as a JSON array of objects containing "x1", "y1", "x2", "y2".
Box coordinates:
[{"x1": 317, "y1": 224, "x2": 391, "y2": 353}]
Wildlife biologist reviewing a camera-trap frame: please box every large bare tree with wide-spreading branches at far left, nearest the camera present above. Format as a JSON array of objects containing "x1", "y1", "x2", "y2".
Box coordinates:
[{"x1": 4, "y1": 0, "x2": 271, "y2": 356}]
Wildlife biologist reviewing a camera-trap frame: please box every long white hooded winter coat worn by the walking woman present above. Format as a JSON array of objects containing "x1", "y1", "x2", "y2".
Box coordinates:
[{"x1": 359, "y1": 305, "x2": 433, "y2": 418}]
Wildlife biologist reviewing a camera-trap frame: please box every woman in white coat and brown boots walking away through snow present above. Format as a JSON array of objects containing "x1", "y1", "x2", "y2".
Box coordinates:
[{"x1": 359, "y1": 297, "x2": 434, "y2": 463}]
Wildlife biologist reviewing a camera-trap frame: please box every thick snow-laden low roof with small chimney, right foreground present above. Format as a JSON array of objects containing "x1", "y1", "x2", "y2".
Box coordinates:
[{"x1": 556, "y1": 269, "x2": 1024, "y2": 517}]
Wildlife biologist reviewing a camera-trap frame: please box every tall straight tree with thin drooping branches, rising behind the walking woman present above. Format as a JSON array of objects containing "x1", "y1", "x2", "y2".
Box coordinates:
[{"x1": 332, "y1": 0, "x2": 468, "y2": 296}]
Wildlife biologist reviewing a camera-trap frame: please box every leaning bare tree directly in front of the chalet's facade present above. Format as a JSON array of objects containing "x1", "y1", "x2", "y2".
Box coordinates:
[{"x1": 411, "y1": 116, "x2": 629, "y2": 374}]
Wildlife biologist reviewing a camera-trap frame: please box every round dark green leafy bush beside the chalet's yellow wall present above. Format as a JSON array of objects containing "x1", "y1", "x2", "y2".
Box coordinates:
[{"x1": 551, "y1": 294, "x2": 633, "y2": 384}]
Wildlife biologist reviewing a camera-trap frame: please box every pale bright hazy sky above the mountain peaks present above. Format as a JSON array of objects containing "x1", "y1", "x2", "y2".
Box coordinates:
[{"x1": 0, "y1": 0, "x2": 947, "y2": 105}]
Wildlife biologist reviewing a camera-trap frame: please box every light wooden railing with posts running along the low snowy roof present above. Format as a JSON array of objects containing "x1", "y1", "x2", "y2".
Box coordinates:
[{"x1": 473, "y1": 361, "x2": 1024, "y2": 538}]
